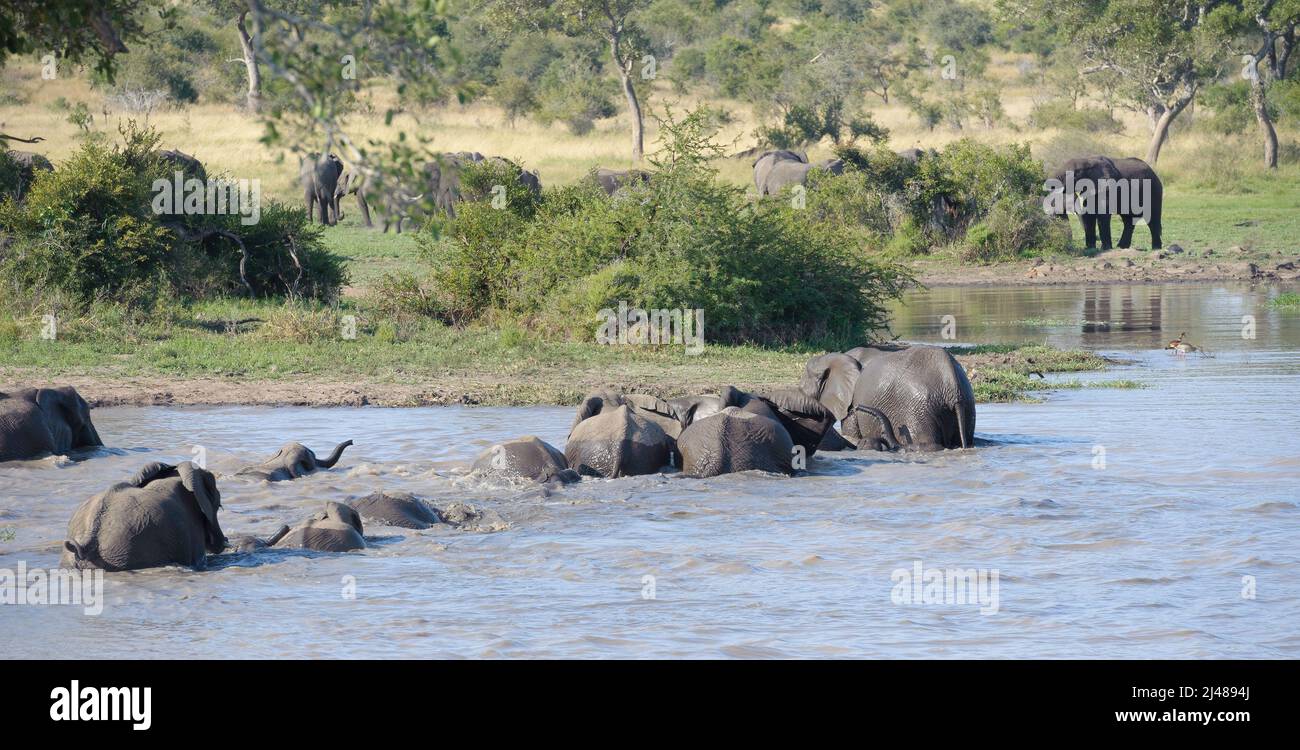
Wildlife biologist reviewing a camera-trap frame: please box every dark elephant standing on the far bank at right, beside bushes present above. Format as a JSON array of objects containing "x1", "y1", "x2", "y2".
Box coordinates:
[{"x1": 1053, "y1": 156, "x2": 1165, "y2": 250}]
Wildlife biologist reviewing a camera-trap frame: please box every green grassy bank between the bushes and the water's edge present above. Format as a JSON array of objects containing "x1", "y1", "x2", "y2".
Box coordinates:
[{"x1": 0, "y1": 295, "x2": 1123, "y2": 406}]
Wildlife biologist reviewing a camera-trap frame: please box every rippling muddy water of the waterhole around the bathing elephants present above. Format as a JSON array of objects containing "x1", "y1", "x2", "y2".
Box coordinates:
[{"x1": 0, "y1": 285, "x2": 1300, "y2": 658}]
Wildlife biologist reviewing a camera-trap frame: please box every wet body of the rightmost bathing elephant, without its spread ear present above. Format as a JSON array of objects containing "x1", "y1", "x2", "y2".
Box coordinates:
[{"x1": 842, "y1": 344, "x2": 975, "y2": 451}]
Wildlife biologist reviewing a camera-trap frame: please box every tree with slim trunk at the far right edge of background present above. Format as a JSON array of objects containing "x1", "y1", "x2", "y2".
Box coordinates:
[{"x1": 1212, "y1": 0, "x2": 1300, "y2": 169}]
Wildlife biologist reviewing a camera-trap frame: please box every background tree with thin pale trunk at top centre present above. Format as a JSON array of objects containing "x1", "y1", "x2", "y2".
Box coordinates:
[{"x1": 485, "y1": 0, "x2": 654, "y2": 161}]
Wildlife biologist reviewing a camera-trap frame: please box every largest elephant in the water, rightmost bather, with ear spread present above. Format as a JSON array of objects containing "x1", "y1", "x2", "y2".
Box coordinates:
[{"x1": 800, "y1": 344, "x2": 975, "y2": 451}]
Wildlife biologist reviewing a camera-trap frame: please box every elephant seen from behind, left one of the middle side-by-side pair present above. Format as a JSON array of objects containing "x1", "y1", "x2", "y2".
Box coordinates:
[{"x1": 564, "y1": 391, "x2": 681, "y2": 478}]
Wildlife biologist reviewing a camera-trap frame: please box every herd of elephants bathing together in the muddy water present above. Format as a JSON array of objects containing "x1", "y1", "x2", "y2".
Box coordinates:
[{"x1": 0, "y1": 344, "x2": 975, "y2": 571}]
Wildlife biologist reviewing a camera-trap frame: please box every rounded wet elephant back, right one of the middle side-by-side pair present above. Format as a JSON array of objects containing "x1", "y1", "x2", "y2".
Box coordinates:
[{"x1": 677, "y1": 407, "x2": 794, "y2": 477}]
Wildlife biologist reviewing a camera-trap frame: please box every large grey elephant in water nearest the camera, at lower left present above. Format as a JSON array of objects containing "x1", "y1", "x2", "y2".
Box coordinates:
[{"x1": 59, "y1": 461, "x2": 226, "y2": 571}]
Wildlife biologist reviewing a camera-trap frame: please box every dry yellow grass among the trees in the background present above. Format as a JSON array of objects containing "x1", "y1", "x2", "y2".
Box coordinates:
[{"x1": 0, "y1": 55, "x2": 1287, "y2": 201}]
